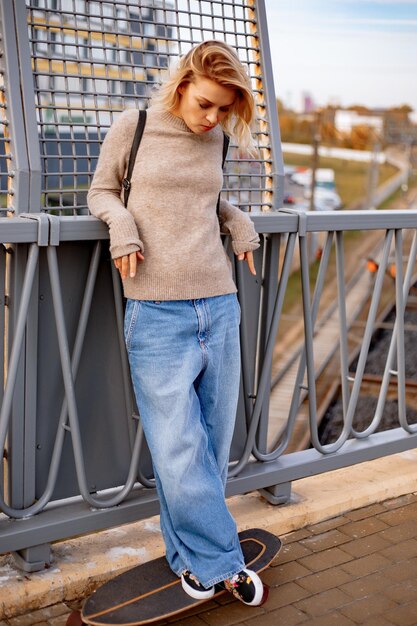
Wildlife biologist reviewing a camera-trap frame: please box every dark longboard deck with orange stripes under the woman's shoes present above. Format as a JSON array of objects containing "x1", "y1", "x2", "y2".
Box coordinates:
[{"x1": 81, "y1": 528, "x2": 281, "y2": 626}]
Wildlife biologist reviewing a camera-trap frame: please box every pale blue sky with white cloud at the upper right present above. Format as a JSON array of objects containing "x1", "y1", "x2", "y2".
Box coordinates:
[{"x1": 265, "y1": 0, "x2": 417, "y2": 111}]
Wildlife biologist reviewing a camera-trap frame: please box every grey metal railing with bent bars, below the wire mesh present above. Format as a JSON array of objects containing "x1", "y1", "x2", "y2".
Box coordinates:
[{"x1": 0, "y1": 211, "x2": 417, "y2": 572}]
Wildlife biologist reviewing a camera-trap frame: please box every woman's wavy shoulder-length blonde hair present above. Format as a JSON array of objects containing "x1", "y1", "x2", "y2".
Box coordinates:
[{"x1": 148, "y1": 40, "x2": 255, "y2": 153}]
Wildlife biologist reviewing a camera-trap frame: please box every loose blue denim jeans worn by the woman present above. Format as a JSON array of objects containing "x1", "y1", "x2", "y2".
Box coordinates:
[{"x1": 125, "y1": 294, "x2": 244, "y2": 587}]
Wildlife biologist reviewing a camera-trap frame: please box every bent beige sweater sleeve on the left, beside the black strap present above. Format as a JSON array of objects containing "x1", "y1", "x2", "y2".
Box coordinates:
[{"x1": 87, "y1": 110, "x2": 144, "y2": 259}]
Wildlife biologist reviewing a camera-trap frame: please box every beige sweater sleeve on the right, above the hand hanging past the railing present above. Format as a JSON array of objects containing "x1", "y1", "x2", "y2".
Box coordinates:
[{"x1": 219, "y1": 199, "x2": 259, "y2": 254}]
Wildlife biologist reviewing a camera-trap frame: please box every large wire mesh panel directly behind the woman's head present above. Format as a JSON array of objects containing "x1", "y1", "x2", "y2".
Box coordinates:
[{"x1": 23, "y1": 0, "x2": 280, "y2": 214}]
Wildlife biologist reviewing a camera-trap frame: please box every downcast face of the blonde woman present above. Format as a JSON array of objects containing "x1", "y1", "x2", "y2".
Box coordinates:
[{"x1": 174, "y1": 77, "x2": 236, "y2": 135}]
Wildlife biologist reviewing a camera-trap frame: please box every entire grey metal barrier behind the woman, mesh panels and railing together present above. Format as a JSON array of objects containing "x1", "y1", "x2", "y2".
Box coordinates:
[{"x1": 0, "y1": 0, "x2": 417, "y2": 571}]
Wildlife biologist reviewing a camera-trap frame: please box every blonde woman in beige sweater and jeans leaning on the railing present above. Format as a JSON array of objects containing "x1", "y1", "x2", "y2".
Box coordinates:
[{"x1": 88, "y1": 41, "x2": 264, "y2": 605}]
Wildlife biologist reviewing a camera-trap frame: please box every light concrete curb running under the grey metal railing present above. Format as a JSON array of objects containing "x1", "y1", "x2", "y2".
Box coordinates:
[{"x1": 0, "y1": 450, "x2": 417, "y2": 619}]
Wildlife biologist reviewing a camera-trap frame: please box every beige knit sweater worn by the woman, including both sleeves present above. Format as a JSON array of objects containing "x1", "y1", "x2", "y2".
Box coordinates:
[{"x1": 88, "y1": 107, "x2": 259, "y2": 300}]
